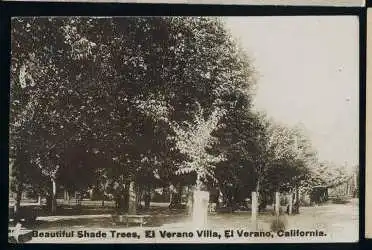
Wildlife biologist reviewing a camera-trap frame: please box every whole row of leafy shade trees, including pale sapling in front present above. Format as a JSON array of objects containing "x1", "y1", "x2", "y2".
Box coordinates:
[{"x1": 9, "y1": 17, "x2": 352, "y2": 217}]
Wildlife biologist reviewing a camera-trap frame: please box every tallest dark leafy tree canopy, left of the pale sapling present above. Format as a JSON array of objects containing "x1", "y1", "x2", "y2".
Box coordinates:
[{"x1": 10, "y1": 17, "x2": 254, "y2": 214}]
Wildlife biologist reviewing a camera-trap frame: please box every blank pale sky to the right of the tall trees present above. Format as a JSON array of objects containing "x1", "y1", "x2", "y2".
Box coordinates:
[{"x1": 226, "y1": 16, "x2": 359, "y2": 165}]
